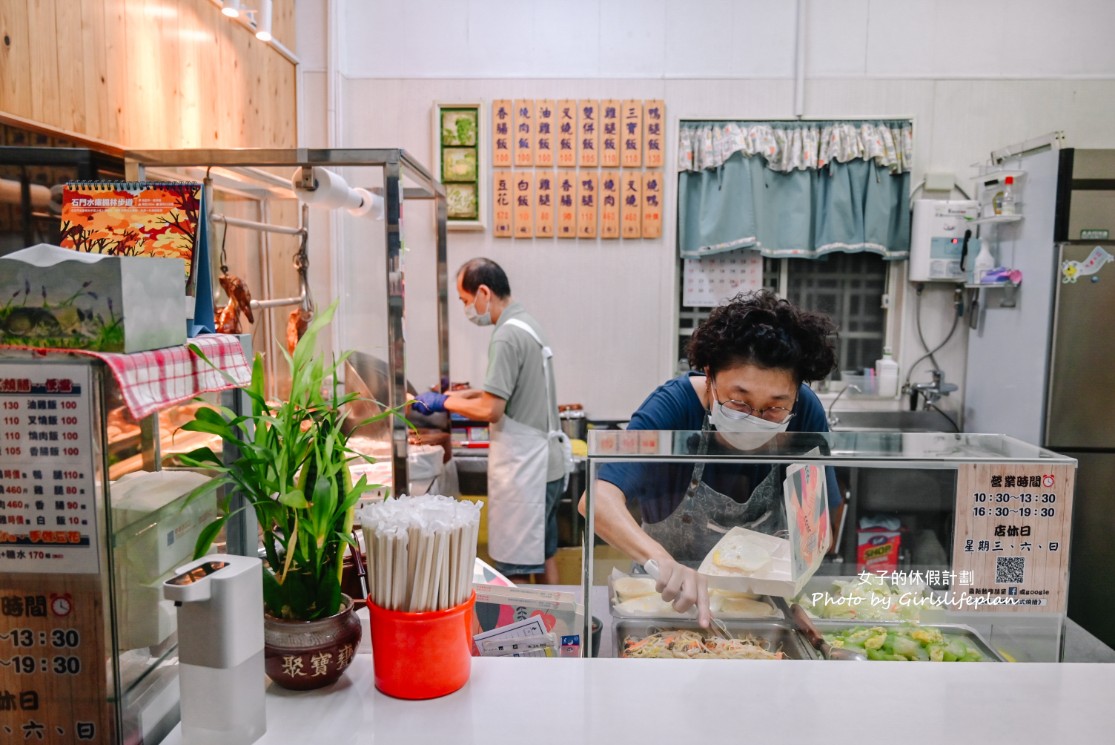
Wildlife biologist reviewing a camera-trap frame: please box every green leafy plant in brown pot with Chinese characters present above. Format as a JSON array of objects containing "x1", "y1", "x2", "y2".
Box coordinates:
[{"x1": 178, "y1": 302, "x2": 394, "y2": 688}]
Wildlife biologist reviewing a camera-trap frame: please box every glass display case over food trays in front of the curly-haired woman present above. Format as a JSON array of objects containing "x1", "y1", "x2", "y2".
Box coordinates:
[{"x1": 583, "y1": 430, "x2": 1076, "y2": 661}]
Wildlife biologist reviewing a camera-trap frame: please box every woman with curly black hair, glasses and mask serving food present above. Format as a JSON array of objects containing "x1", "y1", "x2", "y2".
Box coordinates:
[{"x1": 580, "y1": 290, "x2": 838, "y2": 626}]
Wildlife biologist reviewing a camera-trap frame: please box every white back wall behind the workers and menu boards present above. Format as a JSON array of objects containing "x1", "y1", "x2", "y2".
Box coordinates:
[{"x1": 299, "y1": 0, "x2": 1115, "y2": 418}]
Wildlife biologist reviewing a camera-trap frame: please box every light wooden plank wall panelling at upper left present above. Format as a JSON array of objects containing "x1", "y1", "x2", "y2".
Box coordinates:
[{"x1": 0, "y1": 0, "x2": 297, "y2": 149}]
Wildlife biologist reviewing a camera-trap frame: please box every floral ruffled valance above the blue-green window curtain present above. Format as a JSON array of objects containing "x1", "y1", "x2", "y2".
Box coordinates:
[{"x1": 678, "y1": 120, "x2": 913, "y2": 174}]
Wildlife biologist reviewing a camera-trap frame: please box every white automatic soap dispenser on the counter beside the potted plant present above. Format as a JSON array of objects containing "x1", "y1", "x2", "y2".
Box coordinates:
[{"x1": 163, "y1": 554, "x2": 268, "y2": 745}]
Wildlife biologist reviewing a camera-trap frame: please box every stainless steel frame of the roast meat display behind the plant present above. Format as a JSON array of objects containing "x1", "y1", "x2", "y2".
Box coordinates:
[{"x1": 125, "y1": 148, "x2": 449, "y2": 504}]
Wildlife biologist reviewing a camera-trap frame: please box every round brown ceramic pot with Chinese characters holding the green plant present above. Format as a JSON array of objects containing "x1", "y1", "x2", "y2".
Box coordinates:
[{"x1": 263, "y1": 596, "x2": 361, "y2": 690}]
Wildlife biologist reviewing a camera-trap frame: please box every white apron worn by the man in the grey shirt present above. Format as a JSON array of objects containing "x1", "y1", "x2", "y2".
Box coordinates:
[{"x1": 488, "y1": 318, "x2": 560, "y2": 567}]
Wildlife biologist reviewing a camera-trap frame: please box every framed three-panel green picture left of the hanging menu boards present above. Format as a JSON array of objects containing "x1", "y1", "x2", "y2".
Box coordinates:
[{"x1": 432, "y1": 103, "x2": 487, "y2": 231}]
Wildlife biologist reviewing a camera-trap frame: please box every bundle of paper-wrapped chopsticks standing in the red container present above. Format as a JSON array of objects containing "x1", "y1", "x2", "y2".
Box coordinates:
[{"x1": 357, "y1": 494, "x2": 482, "y2": 612}]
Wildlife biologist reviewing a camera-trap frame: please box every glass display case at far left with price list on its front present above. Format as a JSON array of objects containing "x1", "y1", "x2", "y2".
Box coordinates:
[{"x1": 0, "y1": 349, "x2": 239, "y2": 743}]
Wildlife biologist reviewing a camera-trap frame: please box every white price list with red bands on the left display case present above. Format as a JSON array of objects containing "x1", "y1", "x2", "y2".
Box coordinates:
[{"x1": 0, "y1": 362, "x2": 100, "y2": 574}]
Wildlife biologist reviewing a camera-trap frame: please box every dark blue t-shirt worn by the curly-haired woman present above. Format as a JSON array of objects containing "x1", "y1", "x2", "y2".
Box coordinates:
[{"x1": 599, "y1": 373, "x2": 840, "y2": 523}]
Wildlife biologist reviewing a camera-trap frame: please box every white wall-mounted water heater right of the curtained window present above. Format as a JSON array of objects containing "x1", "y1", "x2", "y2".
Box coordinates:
[{"x1": 910, "y1": 200, "x2": 979, "y2": 282}]
